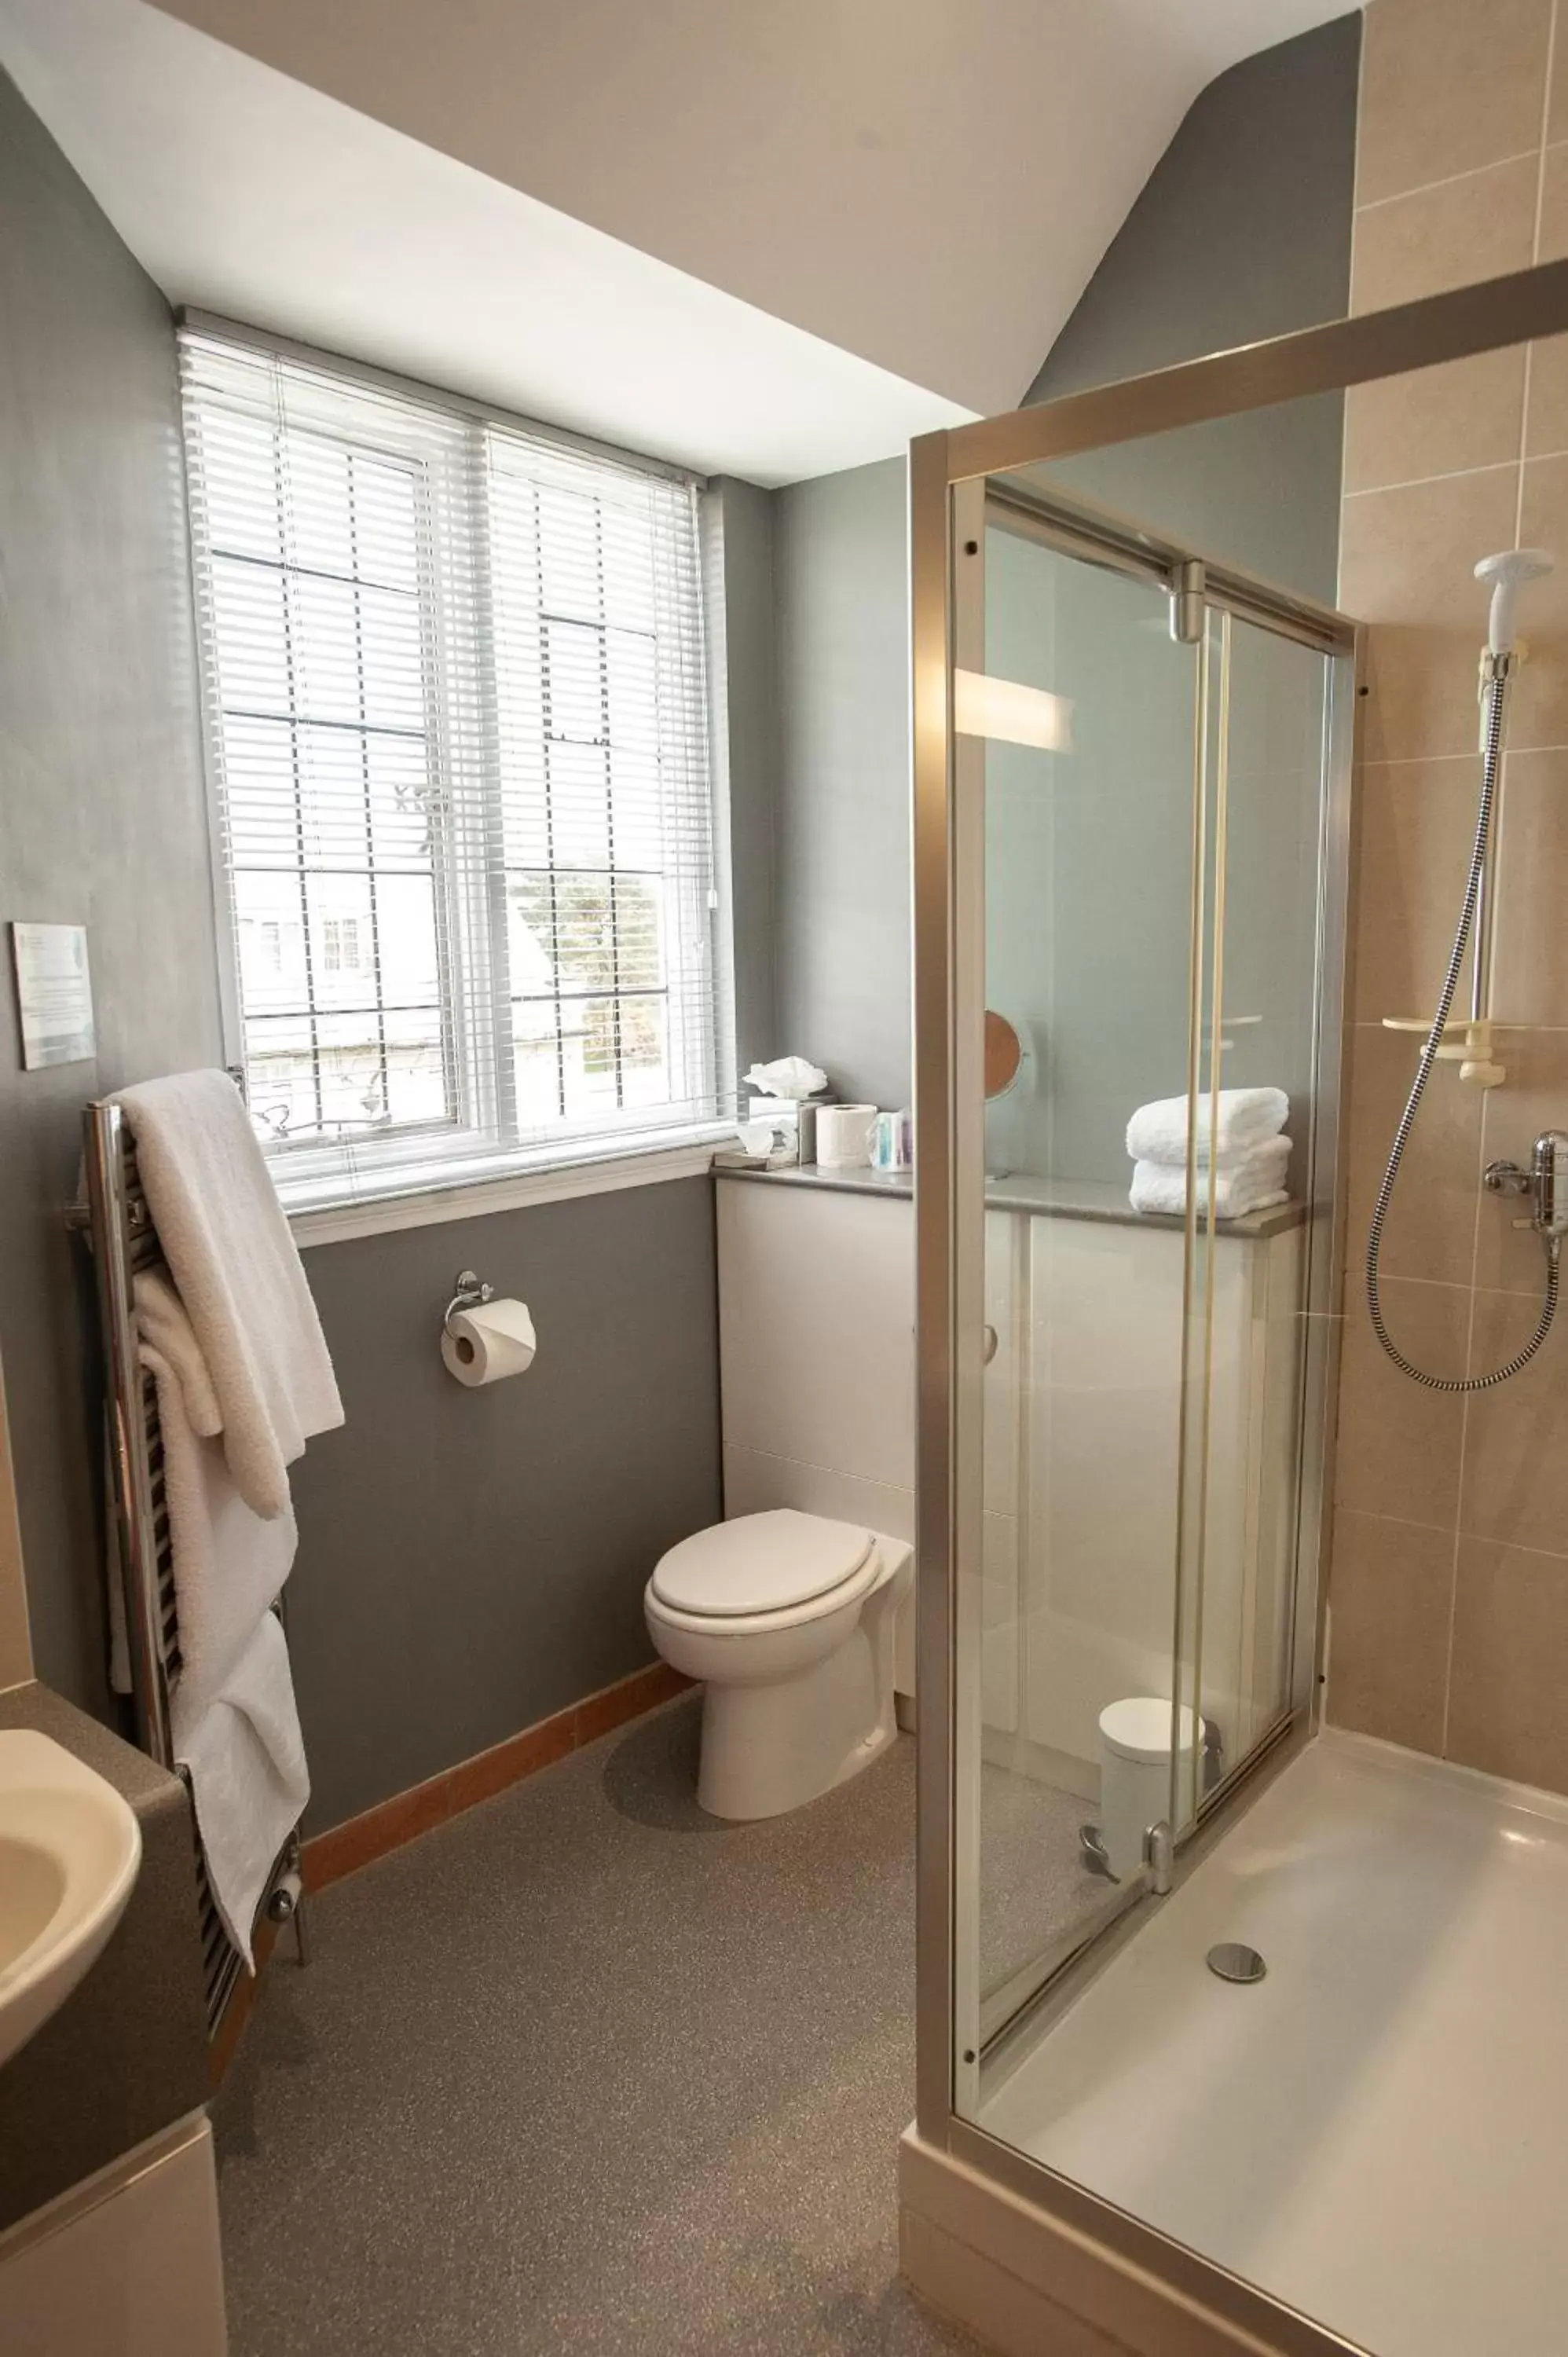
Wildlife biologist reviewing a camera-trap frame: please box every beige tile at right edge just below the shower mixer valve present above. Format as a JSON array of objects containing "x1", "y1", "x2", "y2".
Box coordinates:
[{"x1": 1460, "y1": 1292, "x2": 1568, "y2": 1556}]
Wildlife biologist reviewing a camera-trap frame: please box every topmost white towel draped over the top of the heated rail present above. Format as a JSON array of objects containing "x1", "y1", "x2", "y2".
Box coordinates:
[{"x1": 120, "y1": 1072, "x2": 342, "y2": 1520}]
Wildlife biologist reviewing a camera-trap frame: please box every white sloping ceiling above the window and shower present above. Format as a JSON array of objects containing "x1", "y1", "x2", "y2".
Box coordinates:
[{"x1": 0, "y1": 0, "x2": 1344, "y2": 483}]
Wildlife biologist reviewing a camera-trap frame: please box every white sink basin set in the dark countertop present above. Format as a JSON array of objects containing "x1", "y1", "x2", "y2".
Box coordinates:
[{"x1": 0, "y1": 1728, "x2": 141, "y2": 2062}]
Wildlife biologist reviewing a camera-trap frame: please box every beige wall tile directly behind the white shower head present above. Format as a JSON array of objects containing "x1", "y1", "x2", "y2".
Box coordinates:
[{"x1": 1339, "y1": 462, "x2": 1518, "y2": 761}]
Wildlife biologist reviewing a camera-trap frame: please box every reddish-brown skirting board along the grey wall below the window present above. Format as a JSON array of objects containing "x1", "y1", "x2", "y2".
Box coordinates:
[{"x1": 212, "y1": 1662, "x2": 691, "y2": 2086}]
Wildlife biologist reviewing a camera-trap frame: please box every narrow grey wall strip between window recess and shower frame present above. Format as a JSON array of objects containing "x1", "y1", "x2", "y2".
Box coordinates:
[{"x1": 773, "y1": 460, "x2": 910, "y2": 1108}]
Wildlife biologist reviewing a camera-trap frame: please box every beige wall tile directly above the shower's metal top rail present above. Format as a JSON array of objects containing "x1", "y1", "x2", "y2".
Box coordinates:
[{"x1": 1351, "y1": 156, "x2": 1540, "y2": 311}]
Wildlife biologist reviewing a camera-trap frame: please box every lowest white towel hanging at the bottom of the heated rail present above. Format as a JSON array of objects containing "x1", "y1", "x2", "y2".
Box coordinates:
[{"x1": 174, "y1": 1612, "x2": 311, "y2": 1970}]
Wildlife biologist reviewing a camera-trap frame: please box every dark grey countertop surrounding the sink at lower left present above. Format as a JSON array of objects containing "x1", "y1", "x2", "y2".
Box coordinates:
[{"x1": 0, "y1": 1681, "x2": 210, "y2": 2225}]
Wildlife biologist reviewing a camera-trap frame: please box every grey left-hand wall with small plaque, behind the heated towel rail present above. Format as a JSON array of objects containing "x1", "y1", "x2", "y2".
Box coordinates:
[{"x1": 0, "y1": 75, "x2": 219, "y2": 1714}]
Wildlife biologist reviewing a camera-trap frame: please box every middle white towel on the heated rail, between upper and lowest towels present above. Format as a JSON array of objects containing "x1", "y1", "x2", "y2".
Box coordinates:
[{"x1": 134, "y1": 1275, "x2": 295, "y2": 1725}]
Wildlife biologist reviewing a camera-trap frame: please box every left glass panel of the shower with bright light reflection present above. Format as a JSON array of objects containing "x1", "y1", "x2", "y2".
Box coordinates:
[{"x1": 955, "y1": 511, "x2": 1203, "y2": 2100}]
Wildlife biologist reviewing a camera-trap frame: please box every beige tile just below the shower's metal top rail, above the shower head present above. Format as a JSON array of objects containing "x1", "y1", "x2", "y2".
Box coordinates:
[{"x1": 1344, "y1": 344, "x2": 1526, "y2": 490}]
